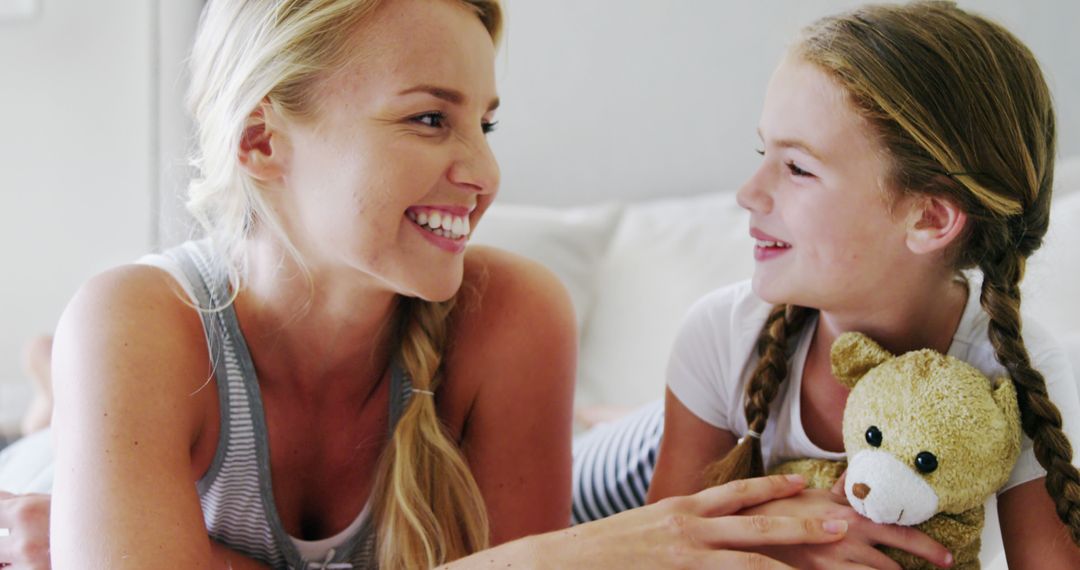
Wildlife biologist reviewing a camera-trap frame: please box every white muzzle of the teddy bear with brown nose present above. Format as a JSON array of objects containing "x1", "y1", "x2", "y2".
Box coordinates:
[{"x1": 843, "y1": 449, "x2": 939, "y2": 526}]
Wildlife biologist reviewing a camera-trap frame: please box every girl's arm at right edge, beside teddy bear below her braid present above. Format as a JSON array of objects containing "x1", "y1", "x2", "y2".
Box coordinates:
[{"x1": 998, "y1": 478, "x2": 1080, "y2": 570}]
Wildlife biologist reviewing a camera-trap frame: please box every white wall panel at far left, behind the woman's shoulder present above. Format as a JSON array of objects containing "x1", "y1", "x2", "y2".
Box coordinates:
[{"x1": 0, "y1": 0, "x2": 156, "y2": 421}]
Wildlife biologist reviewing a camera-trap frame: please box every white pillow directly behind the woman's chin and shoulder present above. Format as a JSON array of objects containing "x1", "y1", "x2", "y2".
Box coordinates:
[{"x1": 470, "y1": 204, "x2": 622, "y2": 330}]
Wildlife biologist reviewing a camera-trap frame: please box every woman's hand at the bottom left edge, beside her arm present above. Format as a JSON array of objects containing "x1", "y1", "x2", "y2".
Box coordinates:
[{"x1": 0, "y1": 491, "x2": 50, "y2": 570}]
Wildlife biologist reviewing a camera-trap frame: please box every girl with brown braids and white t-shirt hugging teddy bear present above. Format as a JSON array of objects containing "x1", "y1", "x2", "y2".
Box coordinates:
[{"x1": 649, "y1": 2, "x2": 1080, "y2": 570}]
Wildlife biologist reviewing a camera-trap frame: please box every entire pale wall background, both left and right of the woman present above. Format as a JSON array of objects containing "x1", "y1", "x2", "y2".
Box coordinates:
[{"x1": 0, "y1": 0, "x2": 1080, "y2": 428}]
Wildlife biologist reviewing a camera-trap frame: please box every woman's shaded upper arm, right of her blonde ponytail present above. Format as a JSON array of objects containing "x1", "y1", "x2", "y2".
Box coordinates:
[{"x1": 448, "y1": 248, "x2": 577, "y2": 544}]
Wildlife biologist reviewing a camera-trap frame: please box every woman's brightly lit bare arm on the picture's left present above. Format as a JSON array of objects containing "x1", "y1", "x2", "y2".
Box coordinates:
[{"x1": 52, "y1": 267, "x2": 240, "y2": 569}]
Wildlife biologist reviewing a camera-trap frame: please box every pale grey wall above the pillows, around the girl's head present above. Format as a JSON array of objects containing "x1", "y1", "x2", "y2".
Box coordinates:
[{"x1": 491, "y1": 0, "x2": 1080, "y2": 205}]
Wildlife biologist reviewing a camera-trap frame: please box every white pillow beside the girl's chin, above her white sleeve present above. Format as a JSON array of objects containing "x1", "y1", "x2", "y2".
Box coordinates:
[{"x1": 578, "y1": 192, "x2": 754, "y2": 406}]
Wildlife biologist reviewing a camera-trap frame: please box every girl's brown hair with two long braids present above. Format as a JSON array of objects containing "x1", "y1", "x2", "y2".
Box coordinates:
[{"x1": 706, "y1": 1, "x2": 1080, "y2": 544}]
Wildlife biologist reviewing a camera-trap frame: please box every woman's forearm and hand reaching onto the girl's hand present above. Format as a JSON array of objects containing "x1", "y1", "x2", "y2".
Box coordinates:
[{"x1": 522, "y1": 476, "x2": 847, "y2": 569}]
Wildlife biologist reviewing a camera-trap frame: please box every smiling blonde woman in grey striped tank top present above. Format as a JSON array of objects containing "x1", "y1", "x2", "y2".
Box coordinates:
[{"x1": 0, "y1": 0, "x2": 846, "y2": 569}]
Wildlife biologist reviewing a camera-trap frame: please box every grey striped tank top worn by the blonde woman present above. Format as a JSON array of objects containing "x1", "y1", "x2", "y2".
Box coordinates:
[{"x1": 157, "y1": 241, "x2": 410, "y2": 570}]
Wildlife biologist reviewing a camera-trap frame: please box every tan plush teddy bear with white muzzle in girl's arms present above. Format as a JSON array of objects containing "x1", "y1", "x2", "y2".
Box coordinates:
[{"x1": 770, "y1": 333, "x2": 1021, "y2": 570}]
